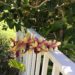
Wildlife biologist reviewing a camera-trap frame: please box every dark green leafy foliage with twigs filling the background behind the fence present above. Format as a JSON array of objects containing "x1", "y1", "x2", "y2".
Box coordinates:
[{"x1": 0, "y1": 0, "x2": 75, "y2": 61}]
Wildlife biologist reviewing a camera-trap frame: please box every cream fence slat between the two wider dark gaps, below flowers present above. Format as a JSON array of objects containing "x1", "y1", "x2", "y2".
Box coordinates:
[{"x1": 41, "y1": 53, "x2": 49, "y2": 75}]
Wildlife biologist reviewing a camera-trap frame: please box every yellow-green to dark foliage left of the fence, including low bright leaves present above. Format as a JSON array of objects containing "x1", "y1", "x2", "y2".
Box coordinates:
[{"x1": 0, "y1": 21, "x2": 24, "y2": 75}]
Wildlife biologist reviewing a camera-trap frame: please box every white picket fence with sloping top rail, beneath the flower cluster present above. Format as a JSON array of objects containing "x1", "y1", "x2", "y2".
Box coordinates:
[{"x1": 17, "y1": 29, "x2": 75, "y2": 75}]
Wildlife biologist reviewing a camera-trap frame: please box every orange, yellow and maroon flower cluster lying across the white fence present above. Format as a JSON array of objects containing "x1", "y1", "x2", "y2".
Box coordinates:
[{"x1": 11, "y1": 33, "x2": 61, "y2": 57}]
